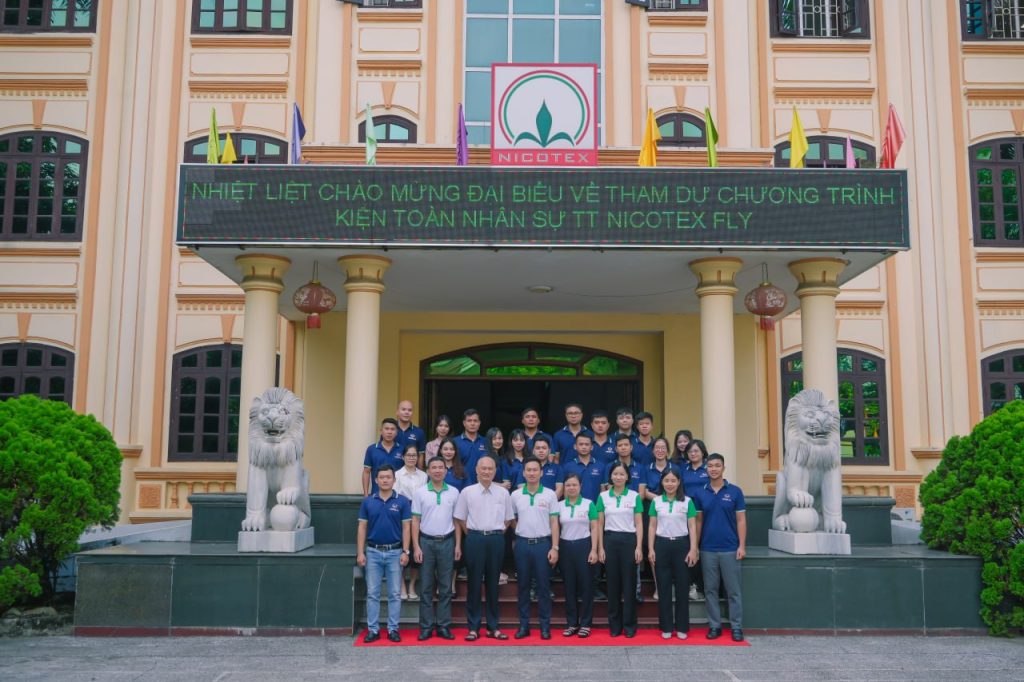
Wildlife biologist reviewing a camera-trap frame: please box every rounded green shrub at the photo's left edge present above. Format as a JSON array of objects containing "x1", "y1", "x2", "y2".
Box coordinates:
[{"x1": 0, "y1": 395, "x2": 121, "y2": 610}]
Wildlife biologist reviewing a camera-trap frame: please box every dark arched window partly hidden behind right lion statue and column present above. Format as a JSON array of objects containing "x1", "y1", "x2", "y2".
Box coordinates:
[{"x1": 779, "y1": 348, "x2": 890, "y2": 466}]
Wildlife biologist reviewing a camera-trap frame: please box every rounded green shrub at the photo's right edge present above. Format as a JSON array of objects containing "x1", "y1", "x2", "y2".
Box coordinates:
[{"x1": 921, "y1": 400, "x2": 1024, "y2": 635}]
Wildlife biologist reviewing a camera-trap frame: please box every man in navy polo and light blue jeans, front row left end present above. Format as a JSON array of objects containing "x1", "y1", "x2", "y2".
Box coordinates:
[{"x1": 355, "y1": 464, "x2": 413, "y2": 644}]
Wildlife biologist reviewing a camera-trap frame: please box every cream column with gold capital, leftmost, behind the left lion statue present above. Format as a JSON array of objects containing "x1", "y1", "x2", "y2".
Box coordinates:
[{"x1": 234, "y1": 254, "x2": 292, "y2": 493}]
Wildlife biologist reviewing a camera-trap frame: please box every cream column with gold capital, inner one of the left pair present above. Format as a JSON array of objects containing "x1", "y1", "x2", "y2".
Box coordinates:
[{"x1": 338, "y1": 255, "x2": 391, "y2": 493}]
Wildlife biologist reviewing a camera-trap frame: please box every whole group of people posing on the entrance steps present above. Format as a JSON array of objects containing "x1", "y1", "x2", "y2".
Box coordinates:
[{"x1": 356, "y1": 400, "x2": 746, "y2": 643}]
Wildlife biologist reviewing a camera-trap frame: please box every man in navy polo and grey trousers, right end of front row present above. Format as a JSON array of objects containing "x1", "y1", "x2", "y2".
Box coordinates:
[{"x1": 696, "y1": 453, "x2": 746, "y2": 642}]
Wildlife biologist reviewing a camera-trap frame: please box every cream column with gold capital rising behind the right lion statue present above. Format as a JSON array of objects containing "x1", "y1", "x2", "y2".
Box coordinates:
[{"x1": 790, "y1": 258, "x2": 847, "y2": 400}]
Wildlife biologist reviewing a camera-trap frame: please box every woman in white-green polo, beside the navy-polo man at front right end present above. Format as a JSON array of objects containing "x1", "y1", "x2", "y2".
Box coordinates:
[{"x1": 647, "y1": 467, "x2": 697, "y2": 639}]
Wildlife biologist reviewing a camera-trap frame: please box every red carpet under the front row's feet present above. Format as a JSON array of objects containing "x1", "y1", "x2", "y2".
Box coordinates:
[{"x1": 355, "y1": 627, "x2": 751, "y2": 648}]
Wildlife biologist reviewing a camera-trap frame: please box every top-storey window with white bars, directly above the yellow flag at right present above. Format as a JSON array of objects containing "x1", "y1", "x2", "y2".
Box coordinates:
[{"x1": 770, "y1": 0, "x2": 870, "y2": 38}]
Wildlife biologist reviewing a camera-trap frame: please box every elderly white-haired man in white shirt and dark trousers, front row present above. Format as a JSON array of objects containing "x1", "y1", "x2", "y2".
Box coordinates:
[{"x1": 455, "y1": 455, "x2": 515, "y2": 642}]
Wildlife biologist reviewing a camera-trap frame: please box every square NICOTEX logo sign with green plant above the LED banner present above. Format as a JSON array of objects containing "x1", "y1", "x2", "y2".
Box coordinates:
[{"x1": 490, "y1": 63, "x2": 597, "y2": 166}]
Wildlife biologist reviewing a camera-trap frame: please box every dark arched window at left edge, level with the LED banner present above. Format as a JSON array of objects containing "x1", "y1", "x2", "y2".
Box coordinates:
[{"x1": 0, "y1": 130, "x2": 89, "y2": 242}]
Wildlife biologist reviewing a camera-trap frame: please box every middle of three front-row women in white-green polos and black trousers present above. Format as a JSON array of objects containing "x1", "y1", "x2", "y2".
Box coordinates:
[{"x1": 597, "y1": 461, "x2": 643, "y2": 637}]
